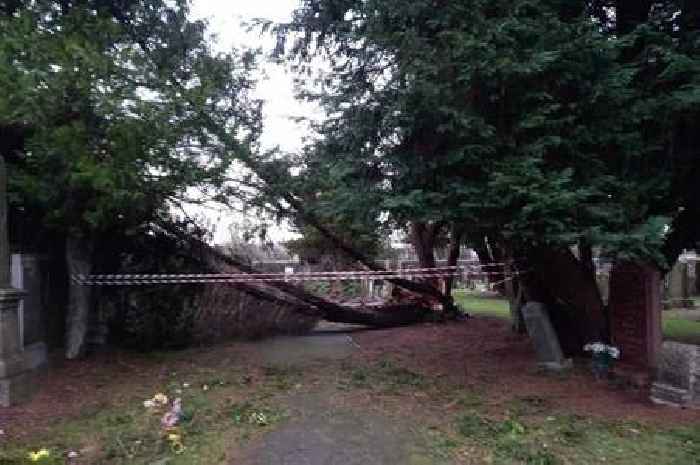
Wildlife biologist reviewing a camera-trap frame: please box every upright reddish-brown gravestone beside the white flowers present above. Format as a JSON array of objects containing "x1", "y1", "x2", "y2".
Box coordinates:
[{"x1": 608, "y1": 262, "x2": 661, "y2": 371}]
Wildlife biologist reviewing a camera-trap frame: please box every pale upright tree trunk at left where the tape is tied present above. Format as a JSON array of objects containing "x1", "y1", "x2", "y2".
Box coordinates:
[{"x1": 66, "y1": 236, "x2": 93, "y2": 359}]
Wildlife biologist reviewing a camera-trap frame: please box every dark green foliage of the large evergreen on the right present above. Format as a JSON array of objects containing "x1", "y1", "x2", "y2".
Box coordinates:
[{"x1": 278, "y1": 0, "x2": 700, "y2": 266}]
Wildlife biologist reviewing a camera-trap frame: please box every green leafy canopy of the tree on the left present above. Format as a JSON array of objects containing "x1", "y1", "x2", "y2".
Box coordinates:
[{"x1": 0, "y1": 0, "x2": 260, "y2": 243}]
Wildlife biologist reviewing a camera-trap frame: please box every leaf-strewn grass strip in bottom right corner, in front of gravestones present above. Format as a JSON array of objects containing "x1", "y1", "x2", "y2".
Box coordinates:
[{"x1": 454, "y1": 410, "x2": 700, "y2": 465}]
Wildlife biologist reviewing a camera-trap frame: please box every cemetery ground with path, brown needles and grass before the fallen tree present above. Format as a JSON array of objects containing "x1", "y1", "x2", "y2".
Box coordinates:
[{"x1": 0, "y1": 316, "x2": 700, "y2": 465}]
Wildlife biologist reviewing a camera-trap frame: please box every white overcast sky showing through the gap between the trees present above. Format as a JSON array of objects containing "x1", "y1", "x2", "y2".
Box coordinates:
[{"x1": 192, "y1": 0, "x2": 318, "y2": 243}]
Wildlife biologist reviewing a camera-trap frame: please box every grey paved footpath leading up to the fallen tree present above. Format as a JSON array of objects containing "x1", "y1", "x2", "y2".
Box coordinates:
[{"x1": 238, "y1": 328, "x2": 434, "y2": 465}]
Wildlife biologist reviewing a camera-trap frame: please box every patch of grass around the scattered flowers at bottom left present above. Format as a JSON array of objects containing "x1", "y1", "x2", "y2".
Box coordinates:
[{"x1": 0, "y1": 358, "x2": 292, "y2": 465}]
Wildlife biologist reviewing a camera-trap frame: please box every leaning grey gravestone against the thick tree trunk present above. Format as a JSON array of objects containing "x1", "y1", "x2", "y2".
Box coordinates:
[{"x1": 522, "y1": 302, "x2": 571, "y2": 371}]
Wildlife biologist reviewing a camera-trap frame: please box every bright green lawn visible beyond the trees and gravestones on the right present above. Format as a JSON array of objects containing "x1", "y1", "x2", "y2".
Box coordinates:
[{"x1": 453, "y1": 290, "x2": 700, "y2": 345}]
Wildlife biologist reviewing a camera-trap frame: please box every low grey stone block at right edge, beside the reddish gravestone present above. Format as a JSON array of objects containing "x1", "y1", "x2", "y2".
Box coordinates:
[{"x1": 651, "y1": 341, "x2": 700, "y2": 408}]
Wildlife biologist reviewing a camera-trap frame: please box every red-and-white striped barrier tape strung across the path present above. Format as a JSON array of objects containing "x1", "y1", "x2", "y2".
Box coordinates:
[{"x1": 71, "y1": 267, "x2": 521, "y2": 286}]
